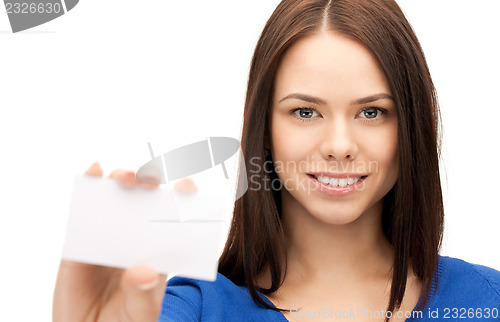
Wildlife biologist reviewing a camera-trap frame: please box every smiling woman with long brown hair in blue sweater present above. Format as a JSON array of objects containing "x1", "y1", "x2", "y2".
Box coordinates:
[{"x1": 54, "y1": 0, "x2": 500, "y2": 321}]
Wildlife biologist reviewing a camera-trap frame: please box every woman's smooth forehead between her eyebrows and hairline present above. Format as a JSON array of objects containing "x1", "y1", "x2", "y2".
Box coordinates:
[{"x1": 274, "y1": 31, "x2": 390, "y2": 104}]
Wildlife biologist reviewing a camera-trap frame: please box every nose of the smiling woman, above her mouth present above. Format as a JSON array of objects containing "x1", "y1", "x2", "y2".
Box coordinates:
[{"x1": 320, "y1": 117, "x2": 358, "y2": 161}]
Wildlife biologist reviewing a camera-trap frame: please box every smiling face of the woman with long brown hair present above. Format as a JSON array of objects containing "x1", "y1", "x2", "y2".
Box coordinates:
[{"x1": 271, "y1": 31, "x2": 398, "y2": 224}]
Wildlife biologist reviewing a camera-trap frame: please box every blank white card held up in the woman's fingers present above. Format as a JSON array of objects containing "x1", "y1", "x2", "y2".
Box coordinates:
[{"x1": 63, "y1": 176, "x2": 229, "y2": 281}]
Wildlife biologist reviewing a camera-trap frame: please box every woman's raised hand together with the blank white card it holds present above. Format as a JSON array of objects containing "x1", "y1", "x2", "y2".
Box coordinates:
[{"x1": 53, "y1": 164, "x2": 229, "y2": 321}]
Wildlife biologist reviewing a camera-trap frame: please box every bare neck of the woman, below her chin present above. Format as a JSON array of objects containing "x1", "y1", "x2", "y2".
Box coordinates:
[{"x1": 282, "y1": 190, "x2": 394, "y2": 283}]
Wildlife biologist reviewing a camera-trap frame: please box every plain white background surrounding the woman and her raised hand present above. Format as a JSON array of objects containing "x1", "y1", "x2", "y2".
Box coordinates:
[{"x1": 0, "y1": 0, "x2": 500, "y2": 321}]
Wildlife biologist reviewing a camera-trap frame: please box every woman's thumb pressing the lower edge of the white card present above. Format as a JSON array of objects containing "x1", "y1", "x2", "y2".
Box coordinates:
[{"x1": 120, "y1": 266, "x2": 167, "y2": 322}]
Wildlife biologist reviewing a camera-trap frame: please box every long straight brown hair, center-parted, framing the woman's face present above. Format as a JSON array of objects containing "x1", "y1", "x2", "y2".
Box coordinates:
[{"x1": 218, "y1": 0, "x2": 444, "y2": 312}]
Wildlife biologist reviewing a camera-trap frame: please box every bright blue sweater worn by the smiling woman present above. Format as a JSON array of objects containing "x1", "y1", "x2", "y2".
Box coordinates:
[{"x1": 158, "y1": 256, "x2": 500, "y2": 322}]
